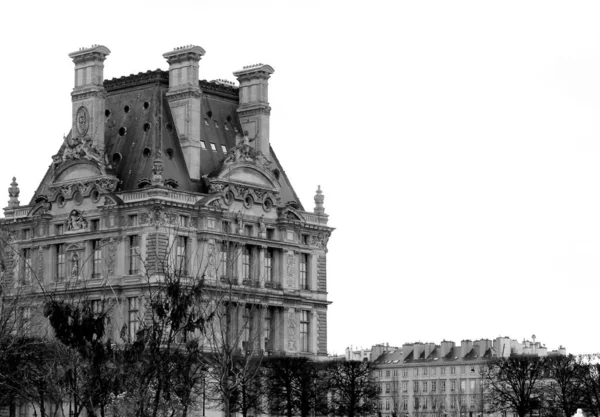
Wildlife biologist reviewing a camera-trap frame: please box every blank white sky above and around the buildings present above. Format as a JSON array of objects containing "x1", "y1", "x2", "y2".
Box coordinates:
[{"x1": 0, "y1": 0, "x2": 600, "y2": 353}]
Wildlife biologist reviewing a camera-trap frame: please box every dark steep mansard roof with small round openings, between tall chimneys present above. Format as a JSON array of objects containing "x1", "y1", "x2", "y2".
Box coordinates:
[{"x1": 30, "y1": 69, "x2": 303, "y2": 209}]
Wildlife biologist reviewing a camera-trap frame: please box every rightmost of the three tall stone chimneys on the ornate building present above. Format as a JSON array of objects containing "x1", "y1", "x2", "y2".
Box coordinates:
[{"x1": 233, "y1": 64, "x2": 275, "y2": 156}]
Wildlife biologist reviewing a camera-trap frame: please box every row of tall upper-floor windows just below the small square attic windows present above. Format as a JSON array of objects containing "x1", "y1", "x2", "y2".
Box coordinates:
[{"x1": 21, "y1": 235, "x2": 311, "y2": 289}]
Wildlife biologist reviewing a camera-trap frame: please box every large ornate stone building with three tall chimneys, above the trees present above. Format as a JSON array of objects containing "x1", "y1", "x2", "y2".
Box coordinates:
[{"x1": 1, "y1": 45, "x2": 333, "y2": 357}]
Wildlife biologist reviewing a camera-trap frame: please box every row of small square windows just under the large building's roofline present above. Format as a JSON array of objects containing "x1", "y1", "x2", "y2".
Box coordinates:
[{"x1": 21, "y1": 214, "x2": 310, "y2": 245}]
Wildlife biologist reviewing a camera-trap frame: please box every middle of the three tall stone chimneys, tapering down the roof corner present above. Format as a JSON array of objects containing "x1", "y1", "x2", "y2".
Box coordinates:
[{"x1": 163, "y1": 45, "x2": 206, "y2": 179}]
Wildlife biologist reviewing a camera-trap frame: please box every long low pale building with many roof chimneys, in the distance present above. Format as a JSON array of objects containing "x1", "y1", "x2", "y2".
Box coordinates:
[{"x1": 372, "y1": 337, "x2": 566, "y2": 417}]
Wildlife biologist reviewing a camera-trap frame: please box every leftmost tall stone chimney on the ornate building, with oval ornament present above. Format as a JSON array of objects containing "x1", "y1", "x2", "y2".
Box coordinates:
[{"x1": 69, "y1": 45, "x2": 110, "y2": 153}]
